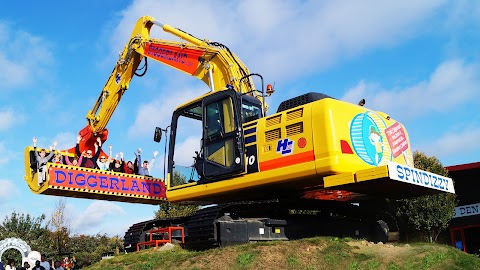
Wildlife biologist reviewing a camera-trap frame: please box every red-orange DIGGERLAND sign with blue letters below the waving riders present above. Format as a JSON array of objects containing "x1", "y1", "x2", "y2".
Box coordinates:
[{"x1": 48, "y1": 166, "x2": 166, "y2": 198}]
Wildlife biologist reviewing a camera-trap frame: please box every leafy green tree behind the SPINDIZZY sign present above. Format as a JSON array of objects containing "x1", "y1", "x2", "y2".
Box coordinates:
[{"x1": 393, "y1": 151, "x2": 456, "y2": 243}]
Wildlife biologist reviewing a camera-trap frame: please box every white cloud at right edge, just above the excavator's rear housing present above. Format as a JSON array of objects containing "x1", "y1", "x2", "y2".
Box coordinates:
[{"x1": 342, "y1": 59, "x2": 480, "y2": 118}]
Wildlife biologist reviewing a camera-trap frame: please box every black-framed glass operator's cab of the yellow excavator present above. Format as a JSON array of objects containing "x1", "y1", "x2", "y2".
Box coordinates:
[{"x1": 168, "y1": 90, "x2": 245, "y2": 186}]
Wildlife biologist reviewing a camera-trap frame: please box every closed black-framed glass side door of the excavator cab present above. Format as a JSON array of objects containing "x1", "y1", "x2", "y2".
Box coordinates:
[{"x1": 201, "y1": 90, "x2": 245, "y2": 181}]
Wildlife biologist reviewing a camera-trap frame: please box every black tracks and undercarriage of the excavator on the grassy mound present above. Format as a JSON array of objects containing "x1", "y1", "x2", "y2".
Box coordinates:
[{"x1": 124, "y1": 200, "x2": 396, "y2": 251}]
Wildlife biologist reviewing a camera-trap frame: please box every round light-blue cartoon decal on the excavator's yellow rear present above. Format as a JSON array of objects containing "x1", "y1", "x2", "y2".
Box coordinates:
[{"x1": 350, "y1": 112, "x2": 392, "y2": 166}]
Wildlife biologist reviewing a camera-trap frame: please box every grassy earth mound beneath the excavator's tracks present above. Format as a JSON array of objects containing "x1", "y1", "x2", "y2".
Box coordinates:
[{"x1": 87, "y1": 237, "x2": 480, "y2": 270}]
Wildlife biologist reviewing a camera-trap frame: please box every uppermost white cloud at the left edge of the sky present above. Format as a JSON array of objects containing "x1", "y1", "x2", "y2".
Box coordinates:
[{"x1": 0, "y1": 22, "x2": 53, "y2": 92}]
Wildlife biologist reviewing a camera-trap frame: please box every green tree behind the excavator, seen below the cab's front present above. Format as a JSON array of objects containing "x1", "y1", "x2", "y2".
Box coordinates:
[{"x1": 155, "y1": 171, "x2": 198, "y2": 219}]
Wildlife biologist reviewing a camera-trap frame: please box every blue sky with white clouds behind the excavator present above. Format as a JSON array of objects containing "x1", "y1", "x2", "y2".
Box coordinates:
[{"x1": 0, "y1": 0, "x2": 480, "y2": 236}]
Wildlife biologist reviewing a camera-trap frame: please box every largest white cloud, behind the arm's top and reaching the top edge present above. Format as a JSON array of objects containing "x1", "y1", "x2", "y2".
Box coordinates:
[{"x1": 110, "y1": 0, "x2": 445, "y2": 80}]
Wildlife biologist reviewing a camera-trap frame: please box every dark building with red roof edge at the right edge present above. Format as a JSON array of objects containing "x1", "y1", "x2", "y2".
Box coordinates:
[{"x1": 446, "y1": 162, "x2": 480, "y2": 254}]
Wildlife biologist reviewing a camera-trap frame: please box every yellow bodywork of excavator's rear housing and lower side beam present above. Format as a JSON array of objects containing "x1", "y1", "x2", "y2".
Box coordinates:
[{"x1": 167, "y1": 99, "x2": 411, "y2": 202}]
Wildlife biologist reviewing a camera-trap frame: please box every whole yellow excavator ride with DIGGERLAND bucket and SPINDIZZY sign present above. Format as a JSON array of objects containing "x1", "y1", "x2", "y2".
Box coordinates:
[{"x1": 24, "y1": 16, "x2": 455, "y2": 250}]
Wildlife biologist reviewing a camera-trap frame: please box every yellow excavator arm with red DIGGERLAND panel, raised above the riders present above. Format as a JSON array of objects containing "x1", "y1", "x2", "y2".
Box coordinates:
[{"x1": 79, "y1": 16, "x2": 266, "y2": 154}]
